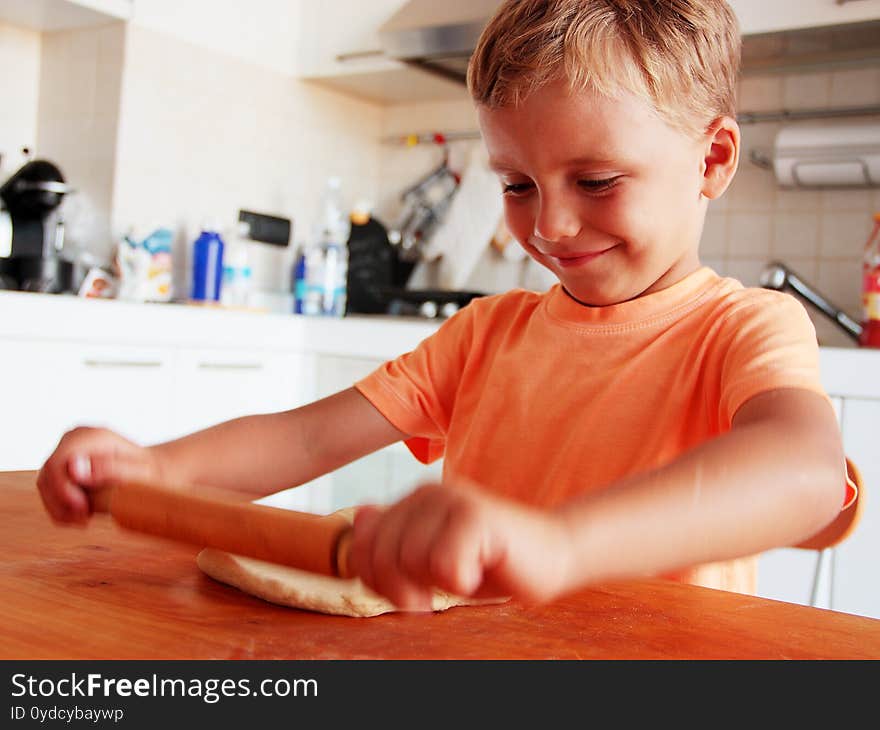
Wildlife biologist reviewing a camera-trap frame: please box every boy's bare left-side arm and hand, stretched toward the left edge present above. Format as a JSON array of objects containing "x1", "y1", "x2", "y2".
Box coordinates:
[{"x1": 37, "y1": 388, "x2": 406, "y2": 522}]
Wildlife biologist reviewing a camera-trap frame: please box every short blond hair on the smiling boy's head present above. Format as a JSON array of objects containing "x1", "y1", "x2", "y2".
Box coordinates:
[{"x1": 468, "y1": 0, "x2": 740, "y2": 135}]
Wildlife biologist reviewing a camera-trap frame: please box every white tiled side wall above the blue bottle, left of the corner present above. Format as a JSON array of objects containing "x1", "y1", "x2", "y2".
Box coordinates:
[{"x1": 113, "y1": 26, "x2": 381, "y2": 293}]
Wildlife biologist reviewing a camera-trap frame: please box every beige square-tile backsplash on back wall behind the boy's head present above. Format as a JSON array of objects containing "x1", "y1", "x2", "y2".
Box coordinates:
[{"x1": 383, "y1": 67, "x2": 880, "y2": 347}]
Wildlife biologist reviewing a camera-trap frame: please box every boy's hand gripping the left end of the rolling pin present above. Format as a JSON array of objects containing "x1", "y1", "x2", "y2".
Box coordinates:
[{"x1": 37, "y1": 427, "x2": 160, "y2": 524}]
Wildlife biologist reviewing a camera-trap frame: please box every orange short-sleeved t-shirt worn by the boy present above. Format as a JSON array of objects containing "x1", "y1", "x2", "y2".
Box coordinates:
[{"x1": 356, "y1": 267, "x2": 844, "y2": 592}]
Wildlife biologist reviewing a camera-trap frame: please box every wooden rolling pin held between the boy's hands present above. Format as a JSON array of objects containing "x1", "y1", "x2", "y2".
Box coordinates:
[{"x1": 92, "y1": 482, "x2": 352, "y2": 578}]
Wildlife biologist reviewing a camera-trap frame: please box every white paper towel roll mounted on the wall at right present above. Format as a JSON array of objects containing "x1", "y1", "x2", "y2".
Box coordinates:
[{"x1": 773, "y1": 121, "x2": 880, "y2": 188}]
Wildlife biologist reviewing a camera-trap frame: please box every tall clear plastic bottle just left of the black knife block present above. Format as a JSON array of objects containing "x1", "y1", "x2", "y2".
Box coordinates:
[{"x1": 303, "y1": 177, "x2": 351, "y2": 317}]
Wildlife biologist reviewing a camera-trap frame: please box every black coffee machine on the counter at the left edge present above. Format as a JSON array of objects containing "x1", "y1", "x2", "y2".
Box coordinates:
[{"x1": 0, "y1": 159, "x2": 73, "y2": 294}]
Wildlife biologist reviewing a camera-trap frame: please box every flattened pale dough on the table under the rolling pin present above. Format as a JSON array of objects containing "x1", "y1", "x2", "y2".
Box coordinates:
[{"x1": 196, "y1": 508, "x2": 507, "y2": 617}]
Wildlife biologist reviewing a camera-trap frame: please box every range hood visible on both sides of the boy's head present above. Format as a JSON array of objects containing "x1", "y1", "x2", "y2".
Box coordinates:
[{"x1": 379, "y1": 0, "x2": 880, "y2": 83}]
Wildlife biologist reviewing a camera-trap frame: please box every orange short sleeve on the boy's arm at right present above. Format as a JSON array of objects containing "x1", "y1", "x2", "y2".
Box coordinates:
[{"x1": 719, "y1": 291, "x2": 828, "y2": 428}]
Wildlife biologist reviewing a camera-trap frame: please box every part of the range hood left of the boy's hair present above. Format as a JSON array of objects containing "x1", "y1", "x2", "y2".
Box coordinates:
[{"x1": 379, "y1": 0, "x2": 501, "y2": 83}]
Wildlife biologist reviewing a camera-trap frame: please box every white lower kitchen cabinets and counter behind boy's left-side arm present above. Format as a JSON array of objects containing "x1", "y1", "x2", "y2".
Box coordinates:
[{"x1": 0, "y1": 292, "x2": 440, "y2": 513}]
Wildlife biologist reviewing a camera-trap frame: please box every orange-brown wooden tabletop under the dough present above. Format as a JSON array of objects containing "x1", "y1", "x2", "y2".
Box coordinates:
[{"x1": 6, "y1": 472, "x2": 880, "y2": 659}]
